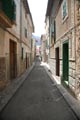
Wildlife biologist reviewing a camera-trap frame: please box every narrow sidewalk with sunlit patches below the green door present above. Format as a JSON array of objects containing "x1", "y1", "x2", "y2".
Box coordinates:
[{"x1": 42, "y1": 62, "x2": 80, "y2": 119}]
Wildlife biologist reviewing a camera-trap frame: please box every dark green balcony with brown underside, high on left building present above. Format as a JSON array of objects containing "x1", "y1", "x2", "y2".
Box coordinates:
[{"x1": 0, "y1": 0, "x2": 15, "y2": 28}]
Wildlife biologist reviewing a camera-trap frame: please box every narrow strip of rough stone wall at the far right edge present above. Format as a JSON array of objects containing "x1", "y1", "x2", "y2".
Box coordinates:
[{"x1": 76, "y1": 0, "x2": 80, "y2": 99}]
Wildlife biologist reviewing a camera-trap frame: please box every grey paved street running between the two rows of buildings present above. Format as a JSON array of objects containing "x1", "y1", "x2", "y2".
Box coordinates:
[{"x1": 0, "y1": 58, "x2": 77, "y2": 120}]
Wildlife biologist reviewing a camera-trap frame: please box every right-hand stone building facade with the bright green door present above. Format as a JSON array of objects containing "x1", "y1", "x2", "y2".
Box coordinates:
[{"x1": 46, "y1": 0, "x2": 80, "y2": 99}]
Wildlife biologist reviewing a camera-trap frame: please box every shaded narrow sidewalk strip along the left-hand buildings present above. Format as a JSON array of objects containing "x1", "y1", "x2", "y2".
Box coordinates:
[{"x1": 0, "y1": 63, "x2": 35, "y2": 112}]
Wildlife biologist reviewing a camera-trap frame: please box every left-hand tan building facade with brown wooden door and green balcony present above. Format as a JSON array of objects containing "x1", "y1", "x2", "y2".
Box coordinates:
[{"x1": 0, "y1": 0, "x2": 34, "y2": 89}]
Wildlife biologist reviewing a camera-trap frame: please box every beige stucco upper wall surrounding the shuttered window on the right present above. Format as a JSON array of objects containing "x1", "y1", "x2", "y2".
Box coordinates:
[{"x1": 56, "y1": 0, "x2": 71, "y2": 40}]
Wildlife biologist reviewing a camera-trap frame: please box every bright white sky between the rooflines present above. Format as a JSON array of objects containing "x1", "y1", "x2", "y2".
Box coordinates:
[{"x1": 28, "y1": 0, "x2": 48, "y2": 36}]
